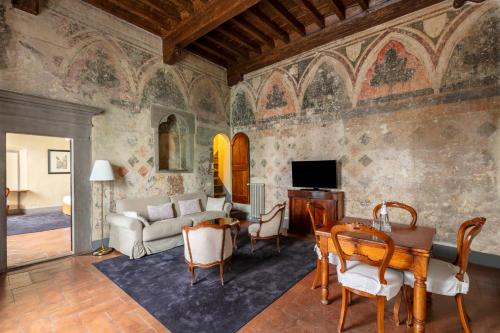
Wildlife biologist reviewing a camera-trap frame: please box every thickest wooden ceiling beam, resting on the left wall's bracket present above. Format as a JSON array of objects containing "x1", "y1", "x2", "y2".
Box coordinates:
[{"x1": 163, "y1": 0, "x2": 260, "y2": 64}]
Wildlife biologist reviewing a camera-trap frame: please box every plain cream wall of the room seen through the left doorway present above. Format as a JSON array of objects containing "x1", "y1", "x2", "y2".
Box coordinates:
[{"x1": 6, "y1": 133, "x2": 71, "y2": 209}]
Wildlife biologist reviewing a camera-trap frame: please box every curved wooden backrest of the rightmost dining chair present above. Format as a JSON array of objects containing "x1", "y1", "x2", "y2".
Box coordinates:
[{"x1": 455, "y1": 217, "x2": 486, "y2": 281}]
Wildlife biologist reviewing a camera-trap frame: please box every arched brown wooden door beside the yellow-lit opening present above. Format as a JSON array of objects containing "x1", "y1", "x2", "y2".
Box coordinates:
[{"x1": 231, "y1": 133, "x2": 250, "y2": 204}]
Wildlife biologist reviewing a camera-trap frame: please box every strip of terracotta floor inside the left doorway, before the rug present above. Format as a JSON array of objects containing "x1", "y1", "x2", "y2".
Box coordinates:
[{"x1": 7, "y1": 228, "x2": 71, "y2": 267}]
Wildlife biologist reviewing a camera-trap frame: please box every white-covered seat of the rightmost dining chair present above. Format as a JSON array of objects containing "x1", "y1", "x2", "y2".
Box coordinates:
[{"x1": 404, "y1": 258, "x2": 469, "y2": 296}]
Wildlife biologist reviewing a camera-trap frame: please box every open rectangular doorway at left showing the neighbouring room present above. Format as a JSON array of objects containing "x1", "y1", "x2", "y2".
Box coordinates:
[{"x1": 5, "y1": 133, "x2": 73, "y2": 268}]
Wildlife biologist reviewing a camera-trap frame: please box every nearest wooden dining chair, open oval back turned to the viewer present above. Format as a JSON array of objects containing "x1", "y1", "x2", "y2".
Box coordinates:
[{"x1": 331, "y1": 223, "x2": 403, "y2": 333}]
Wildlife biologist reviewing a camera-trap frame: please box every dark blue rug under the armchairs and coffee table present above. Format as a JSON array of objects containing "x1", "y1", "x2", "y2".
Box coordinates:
[{"x1": 94, "y1": 229, "x2": 316, "y2": 333}]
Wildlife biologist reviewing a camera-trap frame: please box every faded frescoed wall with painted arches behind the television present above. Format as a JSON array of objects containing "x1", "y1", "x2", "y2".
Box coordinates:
[{"x1": 230, "y1": 0, "x2": 500, "y2": 255}]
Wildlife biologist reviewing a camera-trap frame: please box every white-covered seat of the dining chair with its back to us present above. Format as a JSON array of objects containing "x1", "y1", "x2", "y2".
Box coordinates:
[{"x1": 337, "y1": 261, "x2": 403, "y2": 300}]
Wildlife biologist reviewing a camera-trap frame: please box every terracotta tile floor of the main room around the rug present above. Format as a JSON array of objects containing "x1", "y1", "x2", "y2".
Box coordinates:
[{"x1": 0, "y1": 248, "x2": 500, "y2": 333}]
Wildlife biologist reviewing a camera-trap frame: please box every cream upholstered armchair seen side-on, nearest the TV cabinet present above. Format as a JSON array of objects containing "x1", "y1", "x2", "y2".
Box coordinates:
[{"x1": 248, "y1": 202, "x2": 286, "y2": 252}]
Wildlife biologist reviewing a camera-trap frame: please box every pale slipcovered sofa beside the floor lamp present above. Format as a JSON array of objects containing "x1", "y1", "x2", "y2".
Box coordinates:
[{"x1": 107, "y1": 192, "x2": 232, "y2": 259}]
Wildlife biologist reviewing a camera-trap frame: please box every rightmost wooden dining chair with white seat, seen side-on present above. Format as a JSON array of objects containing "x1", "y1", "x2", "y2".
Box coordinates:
[{"x1": 394, "y1": 217, "x2": 486, "y2": 333}]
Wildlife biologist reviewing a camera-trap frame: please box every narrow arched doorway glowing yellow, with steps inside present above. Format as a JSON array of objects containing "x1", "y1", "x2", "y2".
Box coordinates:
[{"x1": 213, "y1": 133, "x2": 232, "y2": 201}]
